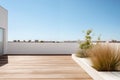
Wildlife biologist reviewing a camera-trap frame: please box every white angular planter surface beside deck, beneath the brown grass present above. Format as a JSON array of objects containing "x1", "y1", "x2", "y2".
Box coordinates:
[{"x1": 72, "y1": 54, "x2": 120, "y2": 80}]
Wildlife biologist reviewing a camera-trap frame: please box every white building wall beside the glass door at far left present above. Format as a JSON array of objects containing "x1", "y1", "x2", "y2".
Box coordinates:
[{"x1": 0, "y1": 6, "x2": 8, "y2": 53}]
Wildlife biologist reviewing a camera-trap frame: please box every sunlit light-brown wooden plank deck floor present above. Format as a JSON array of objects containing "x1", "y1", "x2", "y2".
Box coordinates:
[{"x1": 0, "y1": 55, "x2": 92, "y2": 80}]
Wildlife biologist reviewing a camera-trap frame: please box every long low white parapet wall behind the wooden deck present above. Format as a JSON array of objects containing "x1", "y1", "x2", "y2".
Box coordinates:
[{"x1": 7, "y1": 42, "x2": 79, "y2": 54}]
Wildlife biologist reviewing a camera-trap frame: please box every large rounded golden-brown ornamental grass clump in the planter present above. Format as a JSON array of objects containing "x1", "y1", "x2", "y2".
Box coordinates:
[{"x1": 89, "y1": 44, "x2": 120, "y2": 71}]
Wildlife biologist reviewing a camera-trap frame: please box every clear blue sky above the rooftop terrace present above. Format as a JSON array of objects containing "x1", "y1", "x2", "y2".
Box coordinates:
[{"x1": 0, "y1": 0, "x2": 120, "y2": 40}]
